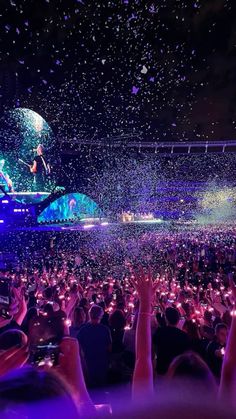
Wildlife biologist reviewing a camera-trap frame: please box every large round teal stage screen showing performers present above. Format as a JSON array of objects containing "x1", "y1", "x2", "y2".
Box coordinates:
[{"x1": 0, "y1": 108, "x2": 59, "y2": 203}]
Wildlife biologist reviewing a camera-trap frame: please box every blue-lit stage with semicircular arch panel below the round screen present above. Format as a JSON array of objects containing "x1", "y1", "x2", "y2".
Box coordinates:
[{"x1": 0, "y1": 187, "x2": 104, "y2": 230}]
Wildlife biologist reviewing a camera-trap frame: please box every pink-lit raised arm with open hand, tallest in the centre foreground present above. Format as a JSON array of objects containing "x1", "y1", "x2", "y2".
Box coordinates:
[{"x1": 132, "y1": 269, "x2": 158, "y2": 402}]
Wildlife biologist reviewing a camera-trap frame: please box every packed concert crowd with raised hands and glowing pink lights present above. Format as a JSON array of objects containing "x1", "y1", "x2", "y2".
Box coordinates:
[{"x1": 0, "y1": 226, "x2": 236, "y2": 418}]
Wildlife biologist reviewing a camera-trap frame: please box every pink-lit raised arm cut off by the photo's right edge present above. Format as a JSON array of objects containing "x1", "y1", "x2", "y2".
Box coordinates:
[{"x1": 219, "y1": 276, "x2": 236, "y2": 405}]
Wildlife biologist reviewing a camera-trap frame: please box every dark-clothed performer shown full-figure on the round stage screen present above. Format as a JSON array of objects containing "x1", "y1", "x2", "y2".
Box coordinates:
[{"x1": 30, "y1": 144, "x2": 51, "y2": 191}]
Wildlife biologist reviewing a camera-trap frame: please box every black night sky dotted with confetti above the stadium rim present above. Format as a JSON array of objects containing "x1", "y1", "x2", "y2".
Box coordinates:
[{"x1": 0, "y1": 0, "x2": 236, "y2": 141}]
